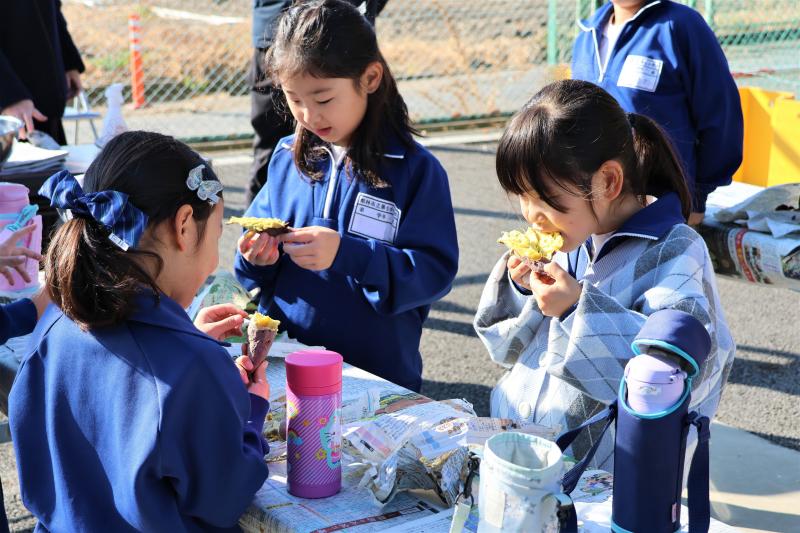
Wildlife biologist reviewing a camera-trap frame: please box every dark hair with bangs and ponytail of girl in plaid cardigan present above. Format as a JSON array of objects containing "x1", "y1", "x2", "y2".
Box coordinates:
[{"x1": 496, "y1": 80, "x2": 692, "y2": 219}]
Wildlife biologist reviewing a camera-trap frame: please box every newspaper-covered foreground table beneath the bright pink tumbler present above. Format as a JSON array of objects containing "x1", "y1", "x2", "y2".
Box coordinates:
[{"x1": 239, "y1": 357, "x2": 735, "y2": 533}]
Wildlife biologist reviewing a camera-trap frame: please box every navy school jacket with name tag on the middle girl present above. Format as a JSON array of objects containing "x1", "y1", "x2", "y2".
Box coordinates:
[{"x1": 234, "y1": 136, "x2": 458, "y2": 391}]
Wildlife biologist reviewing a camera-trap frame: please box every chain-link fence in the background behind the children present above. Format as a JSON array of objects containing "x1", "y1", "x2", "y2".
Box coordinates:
[{"x1": 63, "y1": 0, "x2": 800, "y2": 140}]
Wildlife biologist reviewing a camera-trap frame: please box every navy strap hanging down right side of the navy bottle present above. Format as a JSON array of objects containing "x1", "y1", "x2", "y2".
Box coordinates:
[{"x1": 688, "y1": 411, "x2": 711, "y2": 533}]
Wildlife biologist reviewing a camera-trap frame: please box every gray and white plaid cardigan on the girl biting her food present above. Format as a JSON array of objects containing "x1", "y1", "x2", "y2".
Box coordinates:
[{"x1": 474, "y1": 224, "x2": 735, "y2": 471}]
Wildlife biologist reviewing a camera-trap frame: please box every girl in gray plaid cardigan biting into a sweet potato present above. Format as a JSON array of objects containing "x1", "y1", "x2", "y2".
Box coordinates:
[{"x1": 474, "y1": 80, "x2": 734, "y2": 470}]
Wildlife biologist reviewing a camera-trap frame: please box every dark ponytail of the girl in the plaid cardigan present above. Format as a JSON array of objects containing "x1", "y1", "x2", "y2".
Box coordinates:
[{"x1": 628, "y1": 113, "x2": 692, "y2": 220}]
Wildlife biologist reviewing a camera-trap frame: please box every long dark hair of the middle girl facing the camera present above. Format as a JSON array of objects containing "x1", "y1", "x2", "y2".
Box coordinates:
[{"x1": 266, "y1": 0, "x2": 417, "y2": 186}]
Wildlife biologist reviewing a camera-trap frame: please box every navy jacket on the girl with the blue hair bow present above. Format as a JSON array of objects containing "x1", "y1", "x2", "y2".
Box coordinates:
[{"x1": 9, "y1": 292, "x2": 269, "y2": 532}]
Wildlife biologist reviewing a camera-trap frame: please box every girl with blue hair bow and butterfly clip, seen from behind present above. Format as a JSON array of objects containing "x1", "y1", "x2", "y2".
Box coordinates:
[{"x1": 9, "y1": 132, "x2": 269, "y2": 531}]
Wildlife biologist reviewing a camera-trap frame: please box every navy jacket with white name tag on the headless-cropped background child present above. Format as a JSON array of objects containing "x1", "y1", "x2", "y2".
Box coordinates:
[{"x1": 572, "y1": 0, "x2": 744, "y2": 212}]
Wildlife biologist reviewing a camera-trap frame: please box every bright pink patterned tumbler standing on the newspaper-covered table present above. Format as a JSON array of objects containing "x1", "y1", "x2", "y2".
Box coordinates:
[{"x1": 286, "y1": 350, "x2": 342, "y2": 498}]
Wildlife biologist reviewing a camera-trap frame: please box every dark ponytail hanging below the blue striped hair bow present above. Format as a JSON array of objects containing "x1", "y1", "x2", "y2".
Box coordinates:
[{"x1": 44, "y1": 218, "x2": 163, "y2": 330}]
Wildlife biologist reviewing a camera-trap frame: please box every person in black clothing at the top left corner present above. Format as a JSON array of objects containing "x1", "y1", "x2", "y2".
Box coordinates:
[{"x1": 0, "y1": 0, "x2": 85, "y2": 144}]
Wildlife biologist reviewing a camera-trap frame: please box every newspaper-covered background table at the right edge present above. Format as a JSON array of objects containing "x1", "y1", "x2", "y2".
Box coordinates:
[{"x1": 698, "y1": 182, "x2": 800, "y2": 290}]
